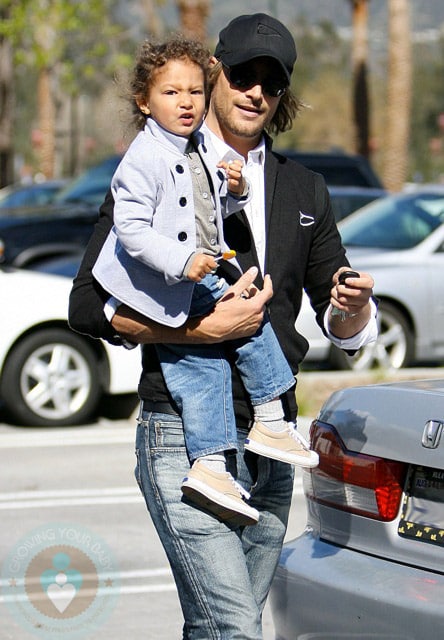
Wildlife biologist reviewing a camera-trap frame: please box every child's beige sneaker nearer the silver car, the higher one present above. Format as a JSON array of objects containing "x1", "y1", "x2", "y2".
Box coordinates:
[{"x1": 245, "y1": 422, "x2": 319, "y2": 467}]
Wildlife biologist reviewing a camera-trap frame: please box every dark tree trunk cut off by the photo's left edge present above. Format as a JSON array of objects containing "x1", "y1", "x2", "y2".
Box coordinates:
[{"x1": 0, "y1": 10, "x2": 14, "y2": 187}]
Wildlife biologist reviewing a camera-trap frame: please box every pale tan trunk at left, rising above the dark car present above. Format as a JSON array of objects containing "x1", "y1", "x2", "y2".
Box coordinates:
[{"x1": 37, "y1": 67, "x2": 55, "y2": 178}]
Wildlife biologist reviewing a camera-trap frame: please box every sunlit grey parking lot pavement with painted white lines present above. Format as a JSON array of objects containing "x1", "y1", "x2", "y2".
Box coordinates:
[{"x1": 0, "y1": 369, "x2": 444, "y2": 640}]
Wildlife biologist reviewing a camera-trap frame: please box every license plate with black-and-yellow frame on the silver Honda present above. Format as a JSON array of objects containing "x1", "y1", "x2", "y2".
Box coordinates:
[{"x1": 398, "y1": 467, "x2": 444, "y2": 546}]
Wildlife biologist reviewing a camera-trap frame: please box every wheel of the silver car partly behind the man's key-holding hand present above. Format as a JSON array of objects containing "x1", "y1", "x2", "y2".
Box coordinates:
[{"x1": 330, "y1": 301, "x2": 414, "y2": 371}]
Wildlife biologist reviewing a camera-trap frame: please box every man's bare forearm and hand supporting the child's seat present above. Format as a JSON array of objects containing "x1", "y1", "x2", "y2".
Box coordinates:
[{"x1": 112, "y1": 267, "x2": 273, "y2": 344}]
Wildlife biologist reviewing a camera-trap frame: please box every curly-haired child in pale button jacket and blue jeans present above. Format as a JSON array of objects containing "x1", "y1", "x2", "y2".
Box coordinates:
[{"x1": 93, "y1": 37, "x2": 318, "y2": 525}]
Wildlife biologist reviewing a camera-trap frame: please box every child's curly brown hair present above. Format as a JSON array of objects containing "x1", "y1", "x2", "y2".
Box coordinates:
[{"x1": 130, "y1": 34, "x2": 210, "y2": 130}]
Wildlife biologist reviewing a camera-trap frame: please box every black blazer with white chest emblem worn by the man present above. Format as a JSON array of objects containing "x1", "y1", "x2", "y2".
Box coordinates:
[{"x1": 69, "y1": 150, "x2": 348, "y2": 423}]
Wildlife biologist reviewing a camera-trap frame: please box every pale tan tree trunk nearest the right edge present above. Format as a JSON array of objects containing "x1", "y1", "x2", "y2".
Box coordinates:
[{"x1": 384, "y1": 0, "x2": 412, "y2": 191}]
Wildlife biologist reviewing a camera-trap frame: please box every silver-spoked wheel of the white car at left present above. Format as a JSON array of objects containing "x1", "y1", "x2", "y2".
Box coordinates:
[{"x1": 1, "y1": 329, "x2": 101, "y2": 426}]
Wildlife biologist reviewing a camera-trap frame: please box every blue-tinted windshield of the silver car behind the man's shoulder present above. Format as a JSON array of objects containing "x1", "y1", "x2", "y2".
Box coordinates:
[{"x1": 339, "y1": 193, "x2": 444, "y2": 249}]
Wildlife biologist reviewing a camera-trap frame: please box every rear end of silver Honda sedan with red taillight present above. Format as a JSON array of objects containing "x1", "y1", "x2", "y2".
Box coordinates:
[{"x1": 271, "y1": 380, "x2": 444, "y2": 640}]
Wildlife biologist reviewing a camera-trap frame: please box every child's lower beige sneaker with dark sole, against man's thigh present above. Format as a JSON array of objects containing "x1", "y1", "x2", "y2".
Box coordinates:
[{"x1": 182, "y1": 460, "x2": 259, "y2": 526}]
